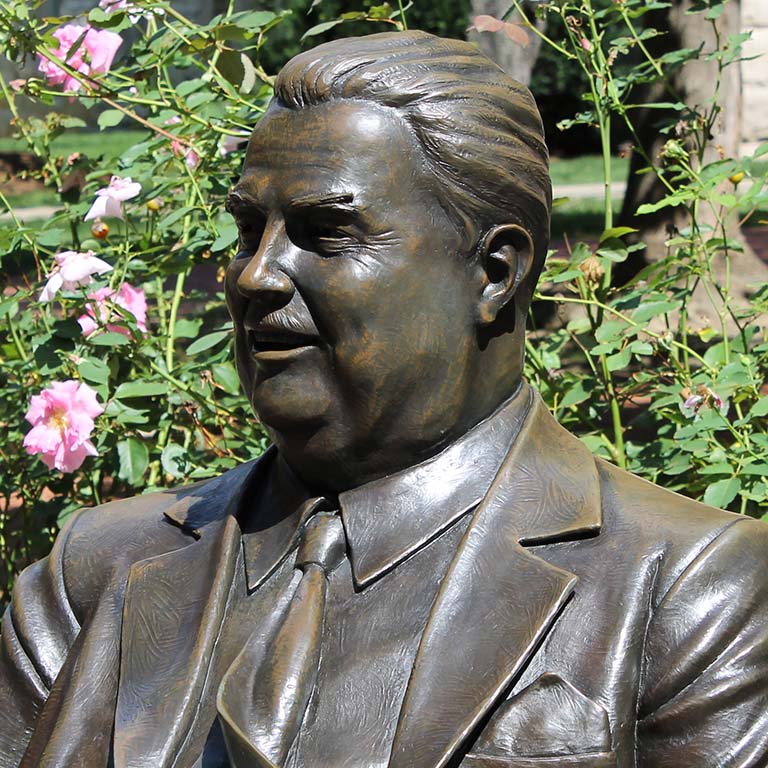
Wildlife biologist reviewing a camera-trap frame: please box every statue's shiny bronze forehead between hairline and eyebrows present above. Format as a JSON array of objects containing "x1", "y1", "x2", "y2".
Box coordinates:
[{"x1": 237, "y1": 100, "x2": 431, "y2": 208}]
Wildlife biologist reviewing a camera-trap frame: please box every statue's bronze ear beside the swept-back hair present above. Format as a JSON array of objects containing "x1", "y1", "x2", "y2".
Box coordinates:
[{"x1": 478, "y1": 224, "x2": 533, "y2": 325}]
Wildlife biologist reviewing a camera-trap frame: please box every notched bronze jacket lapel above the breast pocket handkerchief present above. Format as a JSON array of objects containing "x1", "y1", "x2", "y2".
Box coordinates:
[{"x1": 389, "y1": 393, "x2": 601, "y2": 768}]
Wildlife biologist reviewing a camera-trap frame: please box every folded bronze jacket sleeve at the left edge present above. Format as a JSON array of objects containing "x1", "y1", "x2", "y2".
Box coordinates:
[{"x1": 0, "y1": 513, "x2": 80, "y2": 768}]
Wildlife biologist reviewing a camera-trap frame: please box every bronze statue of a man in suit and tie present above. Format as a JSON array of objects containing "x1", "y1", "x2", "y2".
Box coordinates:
[{"x1": 0, "y1": 32, "x2": 768, "y2": 768}]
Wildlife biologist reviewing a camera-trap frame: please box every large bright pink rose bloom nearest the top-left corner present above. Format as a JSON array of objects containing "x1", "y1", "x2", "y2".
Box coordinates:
[{"x1": 38, "y1": 24, "x2": 123, "y2": 91}]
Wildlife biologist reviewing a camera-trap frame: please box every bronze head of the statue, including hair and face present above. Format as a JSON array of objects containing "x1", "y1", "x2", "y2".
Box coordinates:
[{"x1": 227, "y1": 32, "x2": 551, "y2": 490}]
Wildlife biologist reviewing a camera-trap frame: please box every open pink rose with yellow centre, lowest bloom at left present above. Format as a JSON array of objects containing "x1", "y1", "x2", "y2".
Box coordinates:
[{"x1": 24, "y1": 379, "x2": 104, "y2": 472}]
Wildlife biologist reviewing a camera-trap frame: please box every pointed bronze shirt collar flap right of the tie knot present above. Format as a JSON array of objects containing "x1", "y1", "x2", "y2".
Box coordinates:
[{"x1": 339, "y1": 384, "x2": 531, "y2": 587}]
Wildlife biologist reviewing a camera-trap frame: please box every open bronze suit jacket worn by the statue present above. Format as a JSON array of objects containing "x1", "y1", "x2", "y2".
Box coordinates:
[{"x1": 0, "y1": 396, "x2": 768, "y2": 768}]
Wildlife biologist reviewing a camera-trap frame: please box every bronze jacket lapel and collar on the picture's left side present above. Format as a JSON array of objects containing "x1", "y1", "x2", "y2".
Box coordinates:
[{"x1": 114, "y1": 460, "x2": 266, "y2": 768}]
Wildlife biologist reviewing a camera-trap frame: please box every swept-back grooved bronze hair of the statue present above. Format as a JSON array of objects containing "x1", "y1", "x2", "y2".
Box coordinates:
[{"x1": 275, "y1": 32, "x2": 552, "y2": 291}]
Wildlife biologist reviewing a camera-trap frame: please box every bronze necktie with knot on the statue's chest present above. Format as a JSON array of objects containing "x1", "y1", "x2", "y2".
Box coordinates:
[{"x1": 217, "y1": 505, "x2": 346, "y2": 768}]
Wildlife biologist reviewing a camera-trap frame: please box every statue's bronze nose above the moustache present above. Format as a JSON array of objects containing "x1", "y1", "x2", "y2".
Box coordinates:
[{"x1": 237, "y1": 232, "x2": 294, "y2": 311}]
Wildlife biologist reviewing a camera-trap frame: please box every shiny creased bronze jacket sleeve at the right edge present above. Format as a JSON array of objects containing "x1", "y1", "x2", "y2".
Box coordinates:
[{"x1": 637, "y1": 518, "x2": 768, "y2": 768}]
